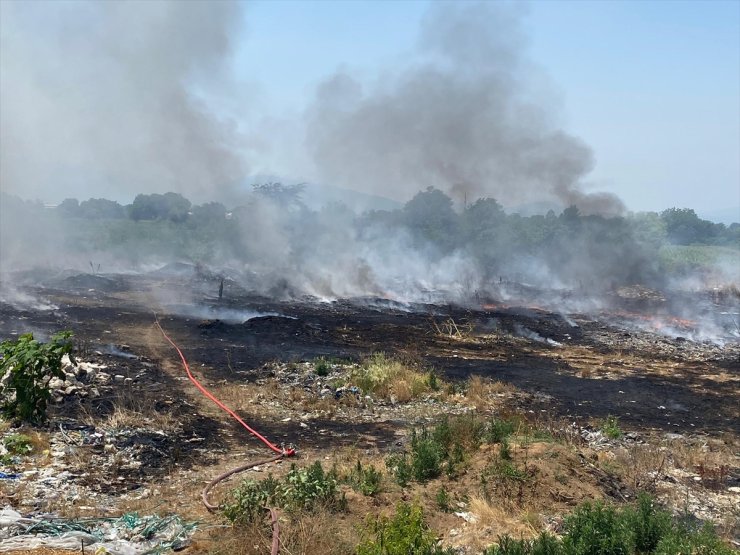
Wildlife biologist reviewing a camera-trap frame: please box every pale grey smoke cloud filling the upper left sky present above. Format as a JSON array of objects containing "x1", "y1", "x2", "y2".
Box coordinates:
[{"x1": 0, "y1": 0, "x2": 246, "y2": 204}]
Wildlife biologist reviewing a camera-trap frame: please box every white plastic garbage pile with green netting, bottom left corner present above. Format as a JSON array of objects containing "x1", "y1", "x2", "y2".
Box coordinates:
[{"x1": 0, "y1": 507, "x2": 197, "y2": 555}]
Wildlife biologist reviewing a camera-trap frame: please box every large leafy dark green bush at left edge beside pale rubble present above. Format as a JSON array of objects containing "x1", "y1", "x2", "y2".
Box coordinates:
[{"x1": 0, "y1": 331, "x2": 75, "y2": 423}]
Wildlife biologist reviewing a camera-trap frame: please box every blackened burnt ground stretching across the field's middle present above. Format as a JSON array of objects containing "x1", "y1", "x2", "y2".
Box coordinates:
[{"x1": 0, "y1": 276, "x2": 740, "y2": 440}]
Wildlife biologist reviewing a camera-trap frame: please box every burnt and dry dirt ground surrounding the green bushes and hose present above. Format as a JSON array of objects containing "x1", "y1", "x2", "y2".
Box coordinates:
[{"x1": 0, "y1": 274, "x2": 740, "y2": 553}]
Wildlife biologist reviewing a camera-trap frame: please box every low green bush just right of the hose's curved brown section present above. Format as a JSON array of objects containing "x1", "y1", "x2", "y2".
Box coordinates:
[{"x1": 222, "y1": 461, "x2": 347, "y2": 523}]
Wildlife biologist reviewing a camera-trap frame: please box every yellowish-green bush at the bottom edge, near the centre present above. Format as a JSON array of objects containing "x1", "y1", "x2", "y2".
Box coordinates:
[{"x1": 357, "y1": 503, "x2": 454, "y2": 555}]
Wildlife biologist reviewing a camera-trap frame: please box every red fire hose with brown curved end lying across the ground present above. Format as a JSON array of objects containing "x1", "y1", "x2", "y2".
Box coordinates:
[{"x1": 154, "y1": 314, "x2": 295, "y2": 555}]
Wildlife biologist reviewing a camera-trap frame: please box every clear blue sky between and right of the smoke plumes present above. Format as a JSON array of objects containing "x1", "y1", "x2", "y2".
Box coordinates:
[{"x1": 234, "y1": 1, "x2": 740, "y2": 219}]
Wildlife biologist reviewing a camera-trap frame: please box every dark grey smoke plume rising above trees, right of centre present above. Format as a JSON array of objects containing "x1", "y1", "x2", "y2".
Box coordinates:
[{"x1": 308, "y1": 3, "x2": 624, "y2": 214}]
